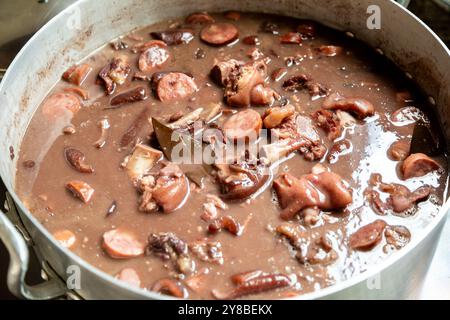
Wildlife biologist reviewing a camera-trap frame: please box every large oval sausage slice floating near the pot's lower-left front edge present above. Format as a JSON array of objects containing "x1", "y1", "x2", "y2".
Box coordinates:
[{"x1": 102, "y1": 229, "x2": 145, "y2": 259}]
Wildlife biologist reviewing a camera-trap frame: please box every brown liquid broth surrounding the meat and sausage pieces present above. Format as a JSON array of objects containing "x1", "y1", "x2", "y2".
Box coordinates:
[{"x1": 16, "y1": 14, "x2": 447, "y2": 299}]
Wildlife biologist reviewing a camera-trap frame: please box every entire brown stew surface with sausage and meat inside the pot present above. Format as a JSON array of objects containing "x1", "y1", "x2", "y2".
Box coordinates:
[{"x1": 16, "y1": 12, "x2": 447, "y2": 299}]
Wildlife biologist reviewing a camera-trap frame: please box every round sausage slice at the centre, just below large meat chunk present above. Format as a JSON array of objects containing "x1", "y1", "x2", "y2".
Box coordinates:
[{"x1": 223, "y1": 109, "x2": 262, "y2": 141}]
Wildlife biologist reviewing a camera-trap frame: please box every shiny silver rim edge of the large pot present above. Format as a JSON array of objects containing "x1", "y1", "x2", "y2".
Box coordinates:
[{"x1": 0, "y1": 0, "x2": 450, "y2": 300}]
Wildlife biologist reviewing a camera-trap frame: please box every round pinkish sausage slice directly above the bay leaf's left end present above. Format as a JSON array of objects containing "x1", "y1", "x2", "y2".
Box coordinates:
[{"x1": 156, "y1": 72, "x2": 198, "y2": 102}]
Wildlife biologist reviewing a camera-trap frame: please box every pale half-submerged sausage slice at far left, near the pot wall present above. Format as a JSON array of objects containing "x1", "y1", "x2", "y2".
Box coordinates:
[{"x1": 42, "y1": 92, "x2": 81, "y2": 120}]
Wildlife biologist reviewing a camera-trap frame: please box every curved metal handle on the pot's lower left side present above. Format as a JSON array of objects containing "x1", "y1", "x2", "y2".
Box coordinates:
[{"x1": 0, "y1": 211, "x2": 67, "y2": 300}]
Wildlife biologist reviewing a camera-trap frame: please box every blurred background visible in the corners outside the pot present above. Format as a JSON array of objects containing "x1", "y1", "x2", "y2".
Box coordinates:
[{"x1": 0, "y1": 0, "x2": 450, "y2": 300}]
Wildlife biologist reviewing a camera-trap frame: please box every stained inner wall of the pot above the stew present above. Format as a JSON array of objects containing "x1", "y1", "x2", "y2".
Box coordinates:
[{"x1": 0, "y1": 0, "x2": 450, "y2": 300}]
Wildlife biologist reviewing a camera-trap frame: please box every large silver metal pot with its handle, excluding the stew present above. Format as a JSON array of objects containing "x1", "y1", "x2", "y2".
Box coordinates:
[{"x1": 0, "y1": 0, "x2": 450, "y2": 299}]
